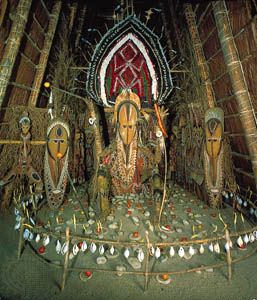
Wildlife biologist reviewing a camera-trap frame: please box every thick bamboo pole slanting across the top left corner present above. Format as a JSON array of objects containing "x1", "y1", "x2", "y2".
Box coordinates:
[{"x1": 0, "y1": 0, "x2": 32, "y2": 107}]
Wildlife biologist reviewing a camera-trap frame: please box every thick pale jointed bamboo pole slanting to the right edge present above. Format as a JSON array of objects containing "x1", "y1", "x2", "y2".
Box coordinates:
[{"x1": 212, "y1": 1, "x2": 257, "y2": 187}]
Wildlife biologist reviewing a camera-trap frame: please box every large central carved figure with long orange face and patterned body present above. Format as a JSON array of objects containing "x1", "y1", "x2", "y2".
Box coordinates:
[{"x1": 97, "y1": 90, "x2": 161, "y2": 215}]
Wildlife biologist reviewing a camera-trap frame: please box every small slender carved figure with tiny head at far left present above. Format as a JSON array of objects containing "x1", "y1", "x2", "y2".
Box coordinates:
[{"x1": 0, "y1": 112, "x2": 43, "y2": 209}]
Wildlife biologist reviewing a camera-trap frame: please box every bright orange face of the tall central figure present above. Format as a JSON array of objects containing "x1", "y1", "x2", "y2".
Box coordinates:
[{"x1": 117, "y1": 101, "x2": 138, "y2": 145}]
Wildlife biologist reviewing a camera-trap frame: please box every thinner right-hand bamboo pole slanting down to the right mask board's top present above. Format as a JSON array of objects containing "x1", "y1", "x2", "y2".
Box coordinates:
[{"x1": 184, "y1": 3, "x2": 216, "y2": 108}]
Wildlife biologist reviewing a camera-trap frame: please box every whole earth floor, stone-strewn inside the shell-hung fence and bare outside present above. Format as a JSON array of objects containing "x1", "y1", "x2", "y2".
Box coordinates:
[{"x1": 0, "y1": 185, "x2": 257, "y2": 300}]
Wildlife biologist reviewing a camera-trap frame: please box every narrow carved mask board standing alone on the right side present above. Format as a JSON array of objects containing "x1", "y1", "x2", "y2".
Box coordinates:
[{"x1": 204, "y1": 107, "x2": 224, "y2": 207}]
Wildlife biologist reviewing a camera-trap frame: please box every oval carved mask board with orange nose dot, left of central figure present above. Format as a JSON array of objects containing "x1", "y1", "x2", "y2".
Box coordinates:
[{"x1": 44, "y1": 119, "x2": 70, "y2": 209}]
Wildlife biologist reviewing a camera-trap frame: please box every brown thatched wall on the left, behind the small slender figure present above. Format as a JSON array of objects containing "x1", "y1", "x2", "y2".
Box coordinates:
[{"x1": 0, "y1": 0, "x2": 52, "y2": 177}]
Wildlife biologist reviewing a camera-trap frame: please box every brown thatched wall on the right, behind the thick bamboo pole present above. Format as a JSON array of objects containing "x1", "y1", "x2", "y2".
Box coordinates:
[{"x1": 190, "y1": 0, "x2": 257, "y2": 198}]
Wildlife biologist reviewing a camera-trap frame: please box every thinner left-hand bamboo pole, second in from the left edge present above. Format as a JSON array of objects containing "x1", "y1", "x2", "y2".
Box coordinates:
[{"x1": 29, "y1": 1, "x2": 62, "y2": 106}]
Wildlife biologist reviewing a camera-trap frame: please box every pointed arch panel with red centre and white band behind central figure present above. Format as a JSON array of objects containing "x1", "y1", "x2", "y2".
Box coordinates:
[{"x1": 86, "y1": 15, "x2": 173, "y2": 107}]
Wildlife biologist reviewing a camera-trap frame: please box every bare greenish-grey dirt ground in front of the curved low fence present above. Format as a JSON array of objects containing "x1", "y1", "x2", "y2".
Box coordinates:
[{"x1": 0, "y1": 188, "x2": 257, "y2": 300}]
